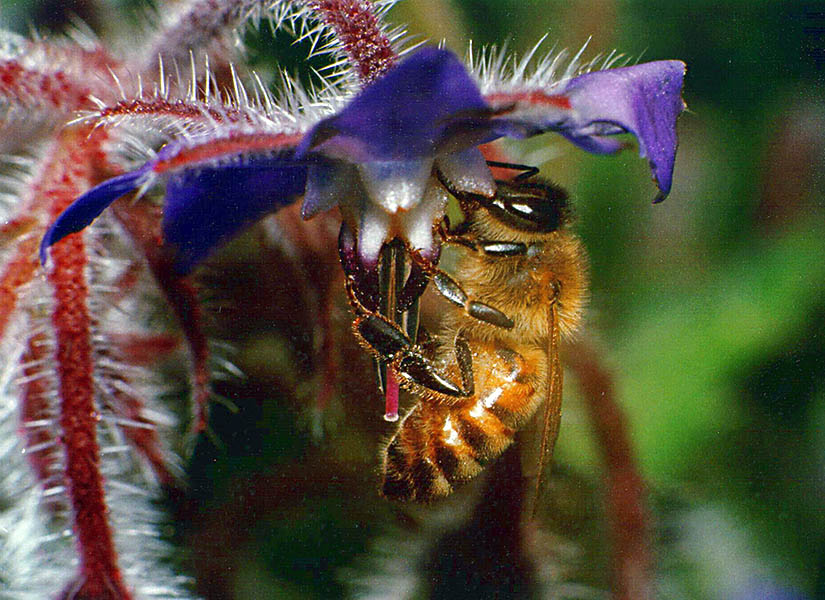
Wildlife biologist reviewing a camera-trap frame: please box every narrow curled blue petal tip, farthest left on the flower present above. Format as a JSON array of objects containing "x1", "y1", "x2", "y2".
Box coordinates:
[{"x1": 40, "y1": 162, "x2": 153, "y2": 264}]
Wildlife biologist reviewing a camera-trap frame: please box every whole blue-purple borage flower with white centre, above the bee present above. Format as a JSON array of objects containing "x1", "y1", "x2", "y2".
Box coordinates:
[{"x1": 42, "y1": 47, "x2": 685, "y2": 272}]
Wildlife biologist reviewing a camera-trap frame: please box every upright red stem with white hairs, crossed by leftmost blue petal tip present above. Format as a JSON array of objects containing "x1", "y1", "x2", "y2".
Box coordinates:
[{"x1": 46, "y1": 131, "x2": 131, "y2": 600}]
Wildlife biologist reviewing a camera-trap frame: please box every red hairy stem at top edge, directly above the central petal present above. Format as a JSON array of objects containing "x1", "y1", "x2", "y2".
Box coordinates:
[{"x1": 310, "y1": 0, "x2": 398, "y2": 85}]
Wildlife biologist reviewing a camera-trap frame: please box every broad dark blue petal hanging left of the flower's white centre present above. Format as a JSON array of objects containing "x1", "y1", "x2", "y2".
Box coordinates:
[{"x1": 163, "y1": 156, "x2": 307, "y2": 273}]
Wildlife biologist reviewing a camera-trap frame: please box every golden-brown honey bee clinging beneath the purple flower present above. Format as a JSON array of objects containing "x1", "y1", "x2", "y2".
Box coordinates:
[{"x1": 350, "y1": 166, "x2": 587, "y2": 502}]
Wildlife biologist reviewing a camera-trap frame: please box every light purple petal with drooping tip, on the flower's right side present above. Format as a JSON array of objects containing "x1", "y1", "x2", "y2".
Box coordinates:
[{"x1": 491, "y1": 60, "x2": 685, "y2": 201}]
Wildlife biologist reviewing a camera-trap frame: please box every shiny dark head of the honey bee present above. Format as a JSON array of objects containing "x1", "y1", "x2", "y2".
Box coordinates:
[{"x1": 478, "y1": 179, "x2": 570, "y2": 234}]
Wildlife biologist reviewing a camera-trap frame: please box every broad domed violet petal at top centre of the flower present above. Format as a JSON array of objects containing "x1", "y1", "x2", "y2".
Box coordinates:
[{"x1": 297, "y1": 48, "x2": 489, "y2": 163}]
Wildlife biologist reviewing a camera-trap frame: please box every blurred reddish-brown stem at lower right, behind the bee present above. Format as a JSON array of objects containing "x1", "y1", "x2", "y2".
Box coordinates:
[{"x1": 564, "y1": 341, "x2": 653, "y2": 600}]
